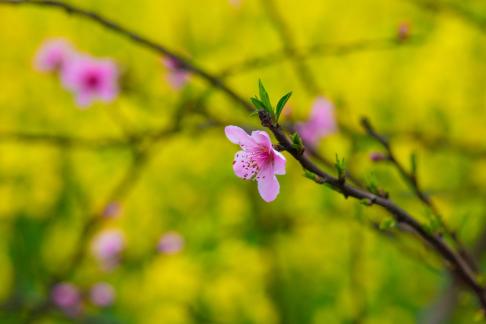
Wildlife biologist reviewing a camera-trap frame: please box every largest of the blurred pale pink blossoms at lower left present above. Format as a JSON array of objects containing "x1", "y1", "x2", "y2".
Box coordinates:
[{"x1": 92, "y1": 230, "x2": 125, "y2": 270}]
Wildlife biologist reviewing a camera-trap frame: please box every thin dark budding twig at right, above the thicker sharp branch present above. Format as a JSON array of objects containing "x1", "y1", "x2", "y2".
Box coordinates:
[{"x1": 361, "y1": 118, "x2": 477, "y2": 272}]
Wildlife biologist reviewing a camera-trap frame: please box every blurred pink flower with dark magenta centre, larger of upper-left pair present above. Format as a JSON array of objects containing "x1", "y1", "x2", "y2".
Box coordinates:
[{"x1": 62, "y1": 55, "x2": 119, "y2": 107}]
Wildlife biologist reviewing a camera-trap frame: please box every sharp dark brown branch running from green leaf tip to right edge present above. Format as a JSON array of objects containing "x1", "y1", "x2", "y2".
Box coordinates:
[{"x1": 259, "y1": 112, "x2": 486, "y2": 311}]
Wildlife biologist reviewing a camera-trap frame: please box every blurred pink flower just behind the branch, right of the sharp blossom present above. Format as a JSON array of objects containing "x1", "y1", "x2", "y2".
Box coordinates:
[{"x1": 296, "y1": 97, "x2": 337, "y2": 146}]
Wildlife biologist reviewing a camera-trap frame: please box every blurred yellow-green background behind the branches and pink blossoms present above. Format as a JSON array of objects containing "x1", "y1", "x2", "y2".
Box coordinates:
[{"x1": 0, "y1": 0, "x2": 486, "y2": 324}]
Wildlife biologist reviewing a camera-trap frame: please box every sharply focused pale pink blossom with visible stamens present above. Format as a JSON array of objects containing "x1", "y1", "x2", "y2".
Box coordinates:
[{"x1": 225, "y1": 126, "x2": 286, "y2": 202}]
